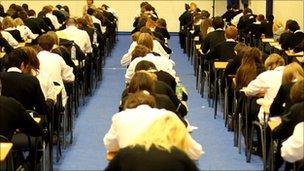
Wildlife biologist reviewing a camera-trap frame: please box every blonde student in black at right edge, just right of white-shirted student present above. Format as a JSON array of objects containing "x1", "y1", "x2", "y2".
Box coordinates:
[{"x1": 270, "y1": 62, "x2": 304, "y2": 116}]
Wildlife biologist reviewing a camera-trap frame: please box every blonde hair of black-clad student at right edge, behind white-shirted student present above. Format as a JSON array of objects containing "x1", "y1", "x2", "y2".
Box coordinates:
[{"x1": 282, "y1": 62, "x2": 304, "y2": 85}]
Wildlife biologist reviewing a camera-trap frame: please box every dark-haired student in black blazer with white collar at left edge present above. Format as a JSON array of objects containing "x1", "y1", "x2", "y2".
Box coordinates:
[{"x1": 0, "y1": 48, "x2": 48, "y2": 115}]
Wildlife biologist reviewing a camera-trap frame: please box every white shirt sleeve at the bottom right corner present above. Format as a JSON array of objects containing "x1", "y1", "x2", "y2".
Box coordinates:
[{"x1": 281, "y1": 122, "x2": 304, "y2": 163}]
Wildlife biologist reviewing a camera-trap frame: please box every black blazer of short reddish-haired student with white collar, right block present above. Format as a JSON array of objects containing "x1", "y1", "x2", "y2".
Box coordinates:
[{"x1": 206, "y1": 41, "x2": 237, "y2": 61}]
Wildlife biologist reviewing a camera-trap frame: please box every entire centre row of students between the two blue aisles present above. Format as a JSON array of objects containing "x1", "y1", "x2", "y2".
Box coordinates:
[{"x1": 103, "y1": 2, "x2": 203, "y2": 170}]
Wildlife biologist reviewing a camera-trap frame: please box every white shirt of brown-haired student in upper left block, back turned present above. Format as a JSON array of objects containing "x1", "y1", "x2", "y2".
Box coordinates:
[{"x1": 56, "y1": 26, "x2": 92, "y2": 53}]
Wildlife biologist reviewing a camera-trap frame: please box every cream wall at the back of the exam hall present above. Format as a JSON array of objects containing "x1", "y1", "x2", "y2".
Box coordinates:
[{"x1": 1, "y1": 0, "x2": 304, "y2": 32}]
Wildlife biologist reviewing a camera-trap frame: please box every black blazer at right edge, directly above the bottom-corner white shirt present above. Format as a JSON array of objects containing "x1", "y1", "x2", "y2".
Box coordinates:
[{"x1": 272, "y1": 102, "x2": 304, "y2": 140}]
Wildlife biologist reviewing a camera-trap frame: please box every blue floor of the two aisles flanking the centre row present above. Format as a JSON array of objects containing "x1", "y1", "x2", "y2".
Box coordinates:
[{"x1": 55, "y1": 35, "x2": 262, "y2": 170}]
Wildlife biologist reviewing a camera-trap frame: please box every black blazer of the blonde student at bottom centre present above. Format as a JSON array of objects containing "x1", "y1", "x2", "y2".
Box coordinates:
[{"x1": 105, "y1": 145, "x2": 198, "y2": 171}]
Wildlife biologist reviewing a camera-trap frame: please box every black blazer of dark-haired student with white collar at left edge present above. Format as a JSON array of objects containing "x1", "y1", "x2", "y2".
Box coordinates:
[{"x1": 0, "y1": 72, "x2": 48, "y2": 115}]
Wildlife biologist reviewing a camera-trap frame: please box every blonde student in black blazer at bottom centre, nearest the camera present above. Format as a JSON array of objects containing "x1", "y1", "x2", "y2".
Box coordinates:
[{"x1": 105, "y1": 113, "x2": 198, "y2": 171}]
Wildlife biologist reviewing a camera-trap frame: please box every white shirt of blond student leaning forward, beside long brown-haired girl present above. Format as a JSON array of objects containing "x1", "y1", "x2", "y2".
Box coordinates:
[{"x1": 245, "y1": 66, "x2": 285, "y2": 121}]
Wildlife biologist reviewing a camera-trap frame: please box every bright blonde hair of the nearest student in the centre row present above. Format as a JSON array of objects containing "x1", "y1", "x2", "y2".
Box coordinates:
[{"x1": 131, "y1": 113, "x2": 190, "y2": 154}]
